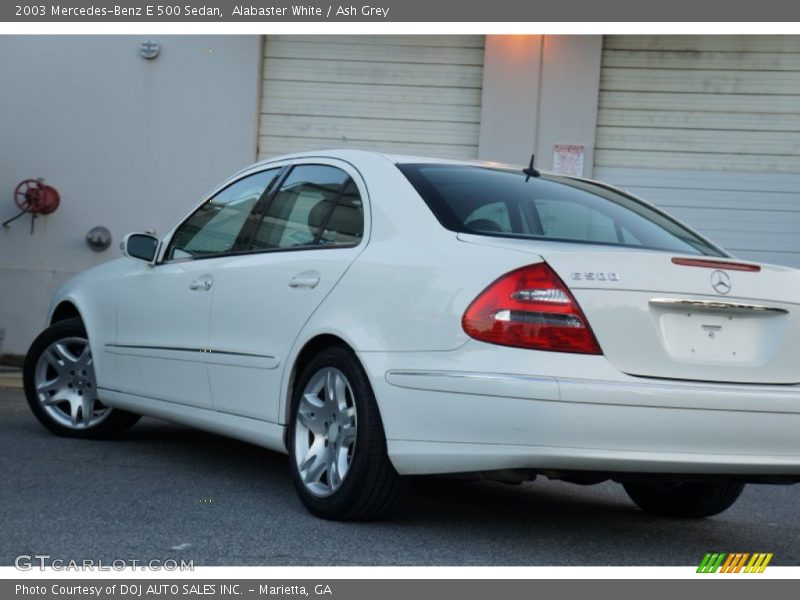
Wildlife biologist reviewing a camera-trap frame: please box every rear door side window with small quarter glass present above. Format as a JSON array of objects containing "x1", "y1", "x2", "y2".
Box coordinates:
[{"x1": 250, "y1": 165, "x2": 364, "y2": 250}]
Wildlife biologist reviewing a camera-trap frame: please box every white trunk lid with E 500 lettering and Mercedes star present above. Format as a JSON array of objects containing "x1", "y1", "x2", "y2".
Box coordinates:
[{"x1": 459, "y1": 234, "x2": 800, "y2": 384}]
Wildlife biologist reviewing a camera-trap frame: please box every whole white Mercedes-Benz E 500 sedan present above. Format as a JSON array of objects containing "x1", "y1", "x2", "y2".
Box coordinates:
[{"x1": 24, "y1": 150, "x2": 800, "y2": 520}]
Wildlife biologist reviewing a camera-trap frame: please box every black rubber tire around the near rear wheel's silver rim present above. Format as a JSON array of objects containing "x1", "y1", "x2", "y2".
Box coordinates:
[{"x1": 287, "y1": 346, "x2": 406, "y2": 521}]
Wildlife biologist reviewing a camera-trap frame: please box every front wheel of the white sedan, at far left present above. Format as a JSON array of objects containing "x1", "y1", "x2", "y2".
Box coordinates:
[{"x1": 22, "y1": 318, "x2": 140, "y2": 439}]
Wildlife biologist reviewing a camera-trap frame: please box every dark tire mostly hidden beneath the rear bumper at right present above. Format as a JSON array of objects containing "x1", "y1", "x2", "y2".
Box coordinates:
[{"x1": 624, "y1": 481, "x2": 744, "y2": 519}]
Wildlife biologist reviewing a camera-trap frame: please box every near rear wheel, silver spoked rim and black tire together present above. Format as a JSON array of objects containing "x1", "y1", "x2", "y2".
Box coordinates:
[{"x1": 287, "y1": 346, "x2": 405, "y2": 521}]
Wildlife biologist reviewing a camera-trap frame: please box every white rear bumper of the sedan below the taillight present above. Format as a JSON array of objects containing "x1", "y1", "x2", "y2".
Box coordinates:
[{"x1": 362, "y1": 350, "x2": 800, "y2": 477}]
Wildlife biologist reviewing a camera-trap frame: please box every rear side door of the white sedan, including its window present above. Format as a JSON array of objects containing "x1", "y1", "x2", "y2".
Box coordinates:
[{"x1": 207, "y1": 161, "x2": 366, "y2": 421}]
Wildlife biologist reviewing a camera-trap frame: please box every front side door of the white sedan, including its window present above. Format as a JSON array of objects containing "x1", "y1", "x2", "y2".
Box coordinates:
[{"x1": 114, "y1": 169, "x2": 280, "y2": 408}]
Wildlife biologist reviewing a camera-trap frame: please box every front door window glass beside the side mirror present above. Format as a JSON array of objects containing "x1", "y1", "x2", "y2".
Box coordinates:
[{"x1": 166, "y1": 169, "x2": 280, "y2": 260}]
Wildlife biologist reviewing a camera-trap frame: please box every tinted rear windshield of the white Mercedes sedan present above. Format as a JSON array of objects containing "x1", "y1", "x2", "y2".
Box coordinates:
[{"x1": 398, "y1": 164, "x2": 725, "y2": 256}]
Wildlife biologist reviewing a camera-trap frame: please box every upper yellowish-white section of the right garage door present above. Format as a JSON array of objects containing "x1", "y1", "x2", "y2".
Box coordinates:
[{"x1": 595, "y1": 36, "x2": 800, "y2": 173}]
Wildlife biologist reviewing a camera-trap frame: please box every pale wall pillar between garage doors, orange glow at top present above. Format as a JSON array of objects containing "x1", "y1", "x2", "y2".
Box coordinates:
[{"x1": 479, "y1": 35, "x2": 603, "y2": 177}]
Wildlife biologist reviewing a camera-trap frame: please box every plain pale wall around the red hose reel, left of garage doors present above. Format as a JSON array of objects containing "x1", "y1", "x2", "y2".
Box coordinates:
[{"x1": 0, "y1": 36, "x2": 261, "y2": 354}]
